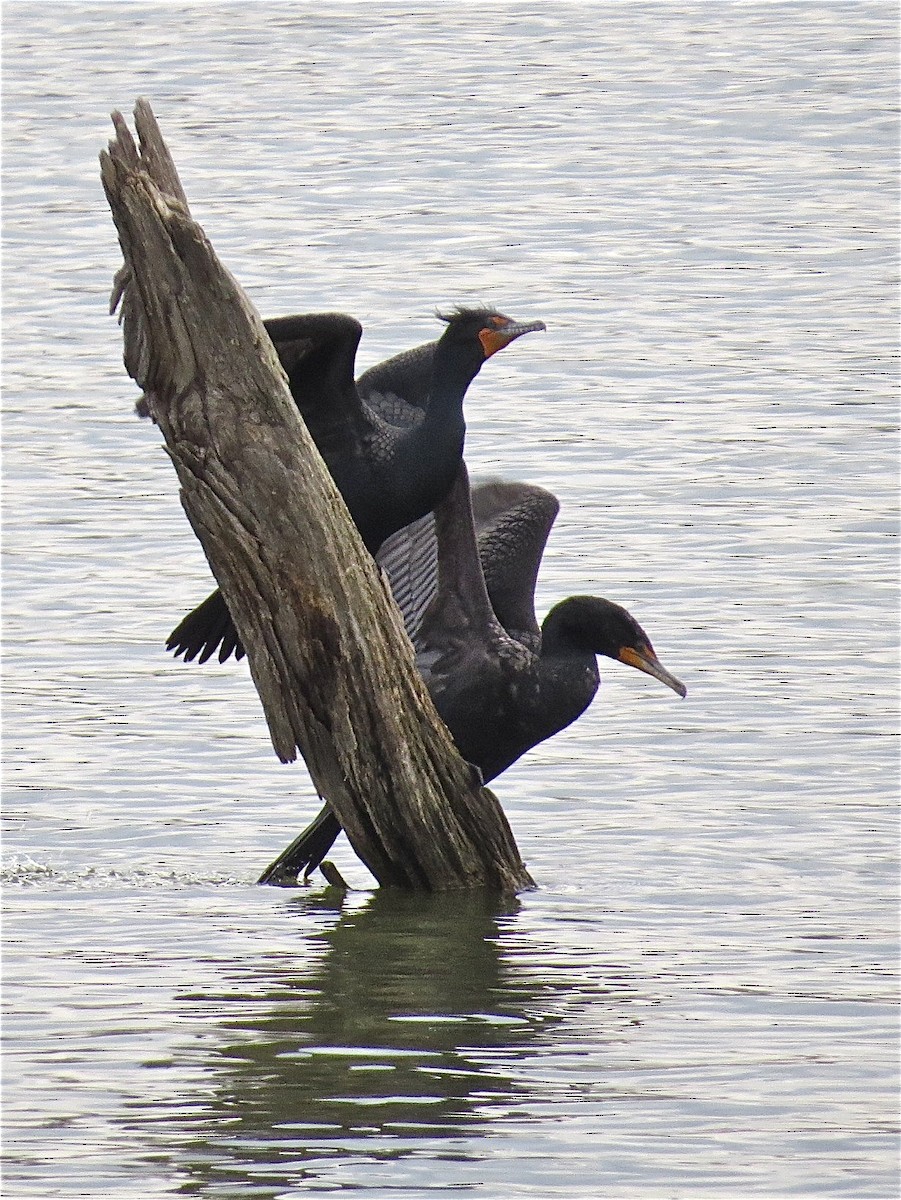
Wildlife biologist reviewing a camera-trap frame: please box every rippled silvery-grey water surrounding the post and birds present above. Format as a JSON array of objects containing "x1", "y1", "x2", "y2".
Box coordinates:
[{"x1": 4, "y1": 0, "x2": 899, "y2": 1200}]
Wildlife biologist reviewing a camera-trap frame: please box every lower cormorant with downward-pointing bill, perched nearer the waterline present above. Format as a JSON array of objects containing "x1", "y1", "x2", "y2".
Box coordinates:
[{"x1": 260, "y1": 462, "x2": 685, "y2": 883}]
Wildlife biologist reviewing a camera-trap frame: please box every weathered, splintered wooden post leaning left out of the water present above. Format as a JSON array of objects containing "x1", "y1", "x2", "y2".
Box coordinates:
[{"x1": 101, "y1": 101, "x2": 531, "y2": 892}]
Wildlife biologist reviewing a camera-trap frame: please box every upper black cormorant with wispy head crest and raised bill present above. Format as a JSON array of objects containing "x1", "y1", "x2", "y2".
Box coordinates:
[{"x1": 166, "y1": 307, "x2": 545, "y2": 662}]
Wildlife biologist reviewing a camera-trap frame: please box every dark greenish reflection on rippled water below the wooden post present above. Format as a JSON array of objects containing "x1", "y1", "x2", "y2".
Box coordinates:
[{"x1": 170, "y1": 889, "x2": 607, "y2": 1194}]
